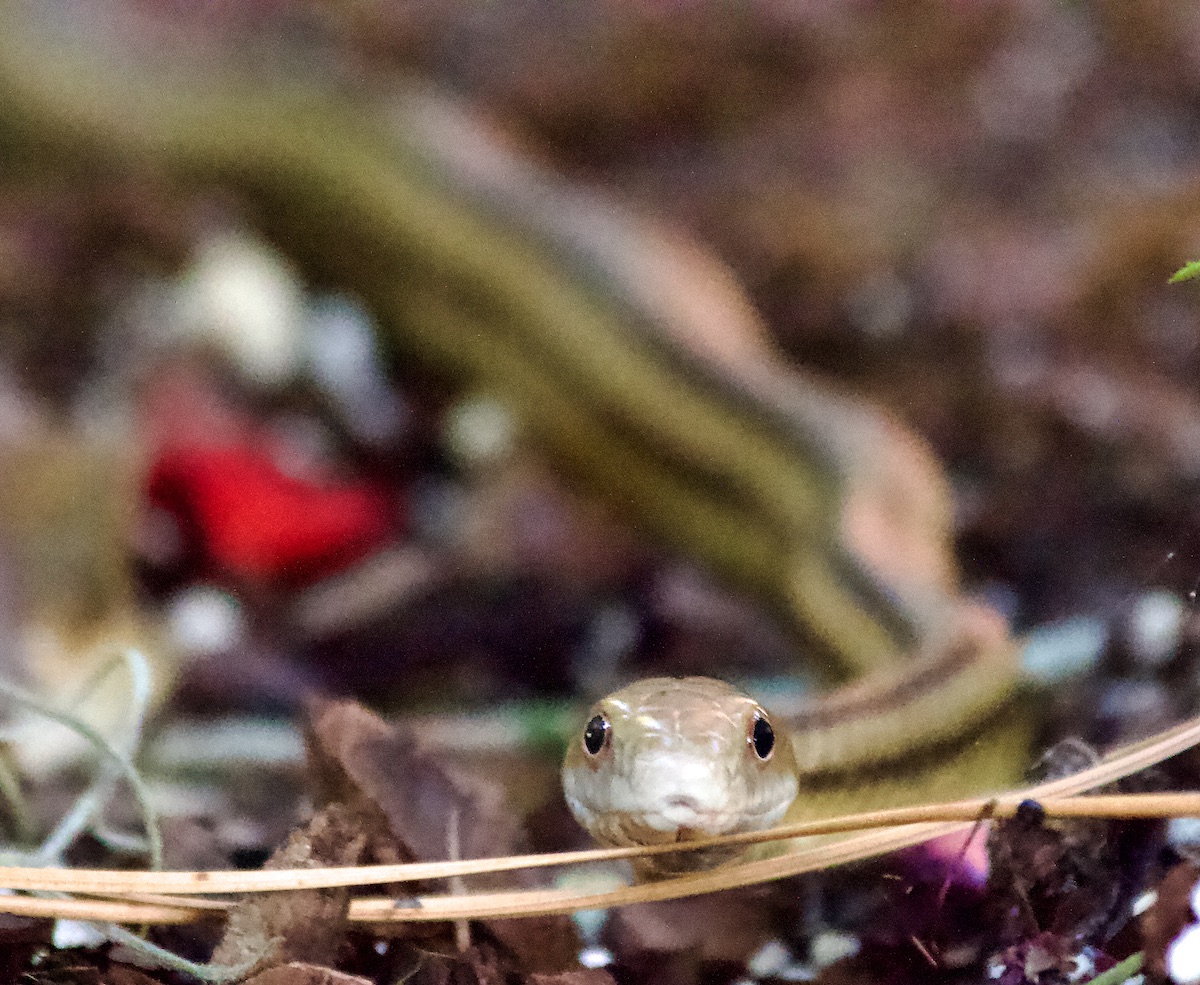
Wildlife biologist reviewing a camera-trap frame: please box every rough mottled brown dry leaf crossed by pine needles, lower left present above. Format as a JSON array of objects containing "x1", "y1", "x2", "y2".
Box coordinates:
[{"x1": 212, "y1": 804, "x2": 368, "y2": 971}]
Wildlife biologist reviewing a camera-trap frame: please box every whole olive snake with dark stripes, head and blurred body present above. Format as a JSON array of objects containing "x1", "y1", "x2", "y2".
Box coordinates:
[{"x1": 0, "y1": 0, "x2": 1027, "y2": 843}]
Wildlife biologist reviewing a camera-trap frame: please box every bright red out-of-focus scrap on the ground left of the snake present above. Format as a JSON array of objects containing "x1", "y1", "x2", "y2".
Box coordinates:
[{"x1": 148, "y1": 443, "x2": 397, "y2": 584}]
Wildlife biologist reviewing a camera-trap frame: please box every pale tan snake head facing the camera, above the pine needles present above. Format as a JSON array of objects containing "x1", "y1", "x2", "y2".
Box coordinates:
[{"x1": 563, "y1": 677, "x2": 797, "y2": 877}]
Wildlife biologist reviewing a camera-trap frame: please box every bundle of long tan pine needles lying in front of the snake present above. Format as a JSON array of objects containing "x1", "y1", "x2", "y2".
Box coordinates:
[{"x1": 0, "y1": 719, "x2": 1200, "y2": 923}]
